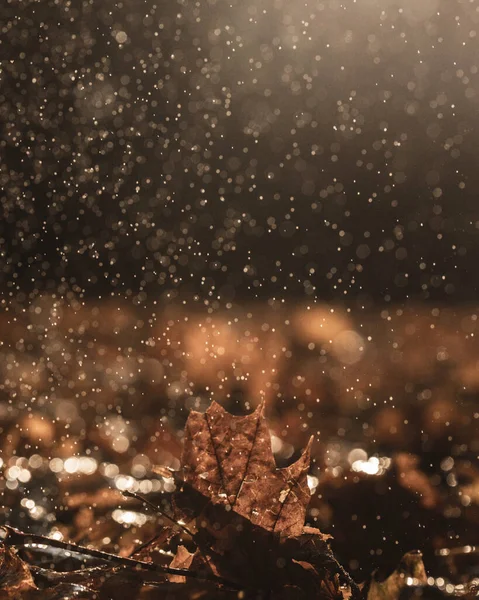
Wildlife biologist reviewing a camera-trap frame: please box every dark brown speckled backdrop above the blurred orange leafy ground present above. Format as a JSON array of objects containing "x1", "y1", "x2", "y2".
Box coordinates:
[{"x1": 0, "y1": 0, "x2": 479, "y2": 305}]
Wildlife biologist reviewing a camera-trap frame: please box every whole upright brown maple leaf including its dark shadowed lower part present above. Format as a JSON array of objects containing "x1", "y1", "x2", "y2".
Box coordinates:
[{"x1": 174, "y1": 402, "x2": 359, "y2": 599}]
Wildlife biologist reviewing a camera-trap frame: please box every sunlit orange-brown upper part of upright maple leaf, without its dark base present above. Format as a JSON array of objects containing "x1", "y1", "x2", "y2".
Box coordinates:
[{"x1": 182, "y1": 402, "x2": 312, "y2": 536}]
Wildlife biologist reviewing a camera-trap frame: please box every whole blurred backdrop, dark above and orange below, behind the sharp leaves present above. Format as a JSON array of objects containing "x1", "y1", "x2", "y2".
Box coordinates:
[{"x1": 0, "y1": 0, "x2": 479, "y2": 593}]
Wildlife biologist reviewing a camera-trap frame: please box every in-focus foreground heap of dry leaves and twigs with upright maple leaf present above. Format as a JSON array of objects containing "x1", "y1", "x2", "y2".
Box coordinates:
[{"x1": 0, "y1": 402, "x2": 475, "y2": 600}]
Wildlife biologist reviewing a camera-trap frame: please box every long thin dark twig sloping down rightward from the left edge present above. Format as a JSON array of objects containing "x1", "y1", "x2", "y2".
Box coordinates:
[{"x1": 0, "y1": 525, "x2": 242, "y2": 590}]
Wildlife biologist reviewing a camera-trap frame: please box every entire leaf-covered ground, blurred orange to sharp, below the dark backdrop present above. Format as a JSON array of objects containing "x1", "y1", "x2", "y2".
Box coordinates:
[{"x1": 0, "y1": 296, "x2": 479, "y2": 600}]
